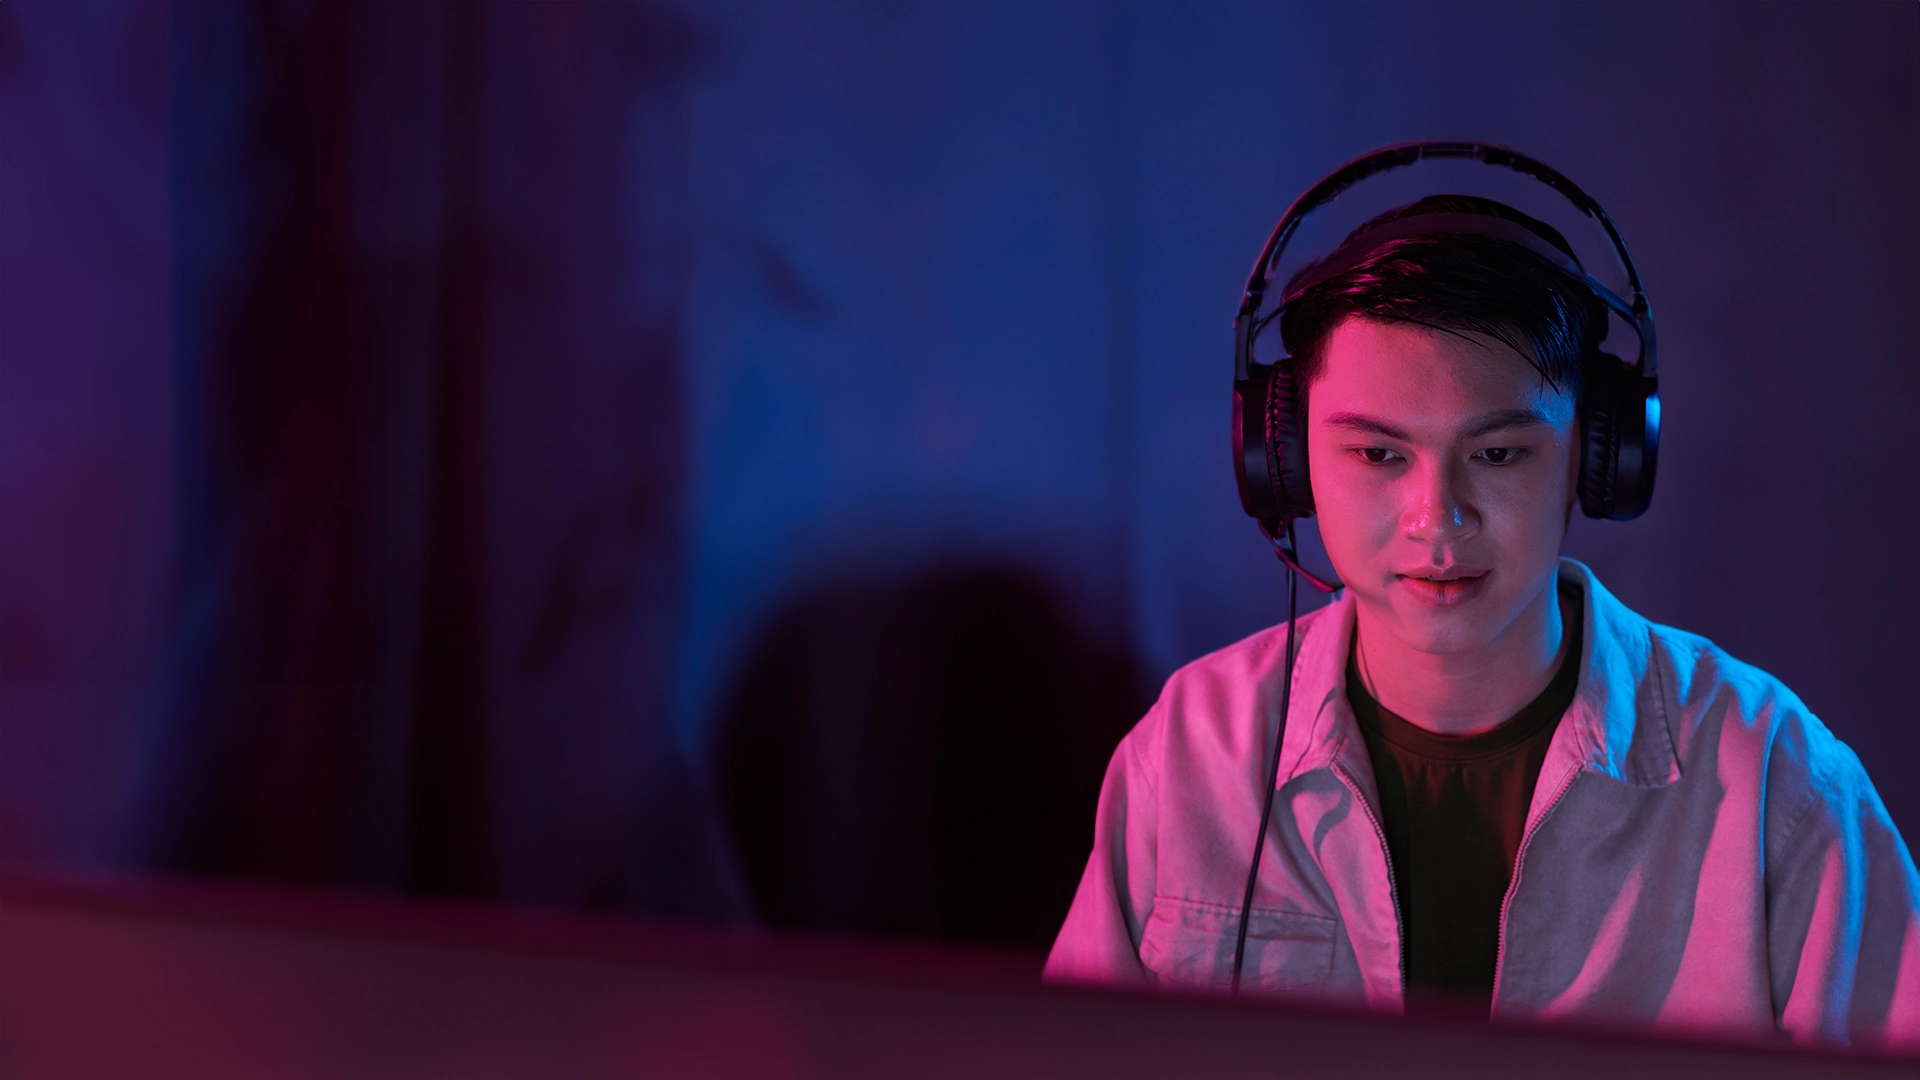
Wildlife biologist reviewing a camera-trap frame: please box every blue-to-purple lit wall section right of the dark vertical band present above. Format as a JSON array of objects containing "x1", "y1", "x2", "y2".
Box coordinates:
[{"x1": 680, "y1": 4, "x2": 1920, "y2": 930}]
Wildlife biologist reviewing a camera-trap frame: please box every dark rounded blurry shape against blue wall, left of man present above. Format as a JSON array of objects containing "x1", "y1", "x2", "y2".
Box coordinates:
[{"x1": 714, "y1": 565, "x2": 1146, "y2": 949}]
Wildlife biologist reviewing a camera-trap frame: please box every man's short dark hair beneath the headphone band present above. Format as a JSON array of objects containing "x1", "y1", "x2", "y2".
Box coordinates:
[{"x1": 1281, "y1": 194, "x2": 1607, "y2": 400}]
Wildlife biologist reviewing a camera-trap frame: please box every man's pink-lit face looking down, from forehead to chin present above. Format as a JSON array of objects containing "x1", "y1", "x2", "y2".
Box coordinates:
[{"x1": 1308, "y1": 317, "x2": 1574, "y2": 655}]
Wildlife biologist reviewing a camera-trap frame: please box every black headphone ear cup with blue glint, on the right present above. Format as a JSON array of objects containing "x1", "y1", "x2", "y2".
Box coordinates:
[{"x1": 1578, "y1": 352, "x2": 1661, "y2": 521}]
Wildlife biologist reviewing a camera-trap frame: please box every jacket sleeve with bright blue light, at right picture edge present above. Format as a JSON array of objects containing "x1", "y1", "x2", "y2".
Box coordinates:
[{"x1": 1766, "y1": 732, "x2": 1920, "y2": 1053}]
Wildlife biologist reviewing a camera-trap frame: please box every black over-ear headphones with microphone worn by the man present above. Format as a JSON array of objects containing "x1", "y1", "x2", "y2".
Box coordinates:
[{"x1": 1233, "y1": 142, "x2": 1661, "y2": 592}]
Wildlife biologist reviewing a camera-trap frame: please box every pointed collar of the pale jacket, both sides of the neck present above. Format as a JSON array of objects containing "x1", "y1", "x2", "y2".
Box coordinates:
[{"x1": 1275, "y1": 557, "x2": 1680, "y2": 788}]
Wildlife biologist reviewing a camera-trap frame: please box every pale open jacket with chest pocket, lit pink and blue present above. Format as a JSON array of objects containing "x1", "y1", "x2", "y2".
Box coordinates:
[{"x1": 1046, "y1": 559, "x2": 1920, "y2": 1049}]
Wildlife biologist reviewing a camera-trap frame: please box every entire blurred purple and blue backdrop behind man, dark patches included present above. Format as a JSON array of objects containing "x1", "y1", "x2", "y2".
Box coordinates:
[{"x1": 0, "y1": 2, "x2": 1920, "y2": 942}]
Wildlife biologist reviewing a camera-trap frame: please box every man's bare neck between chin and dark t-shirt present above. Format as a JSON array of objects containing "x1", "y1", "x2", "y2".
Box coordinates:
[{"x1": 1354, "y1": 580, "x2": 1567, "y2": 734}]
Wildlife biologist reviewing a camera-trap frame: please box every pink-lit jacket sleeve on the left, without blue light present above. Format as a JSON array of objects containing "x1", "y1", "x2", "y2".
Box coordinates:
[{"x1": 1043, "y1": 713, "x2": 1158, "y2": 986}]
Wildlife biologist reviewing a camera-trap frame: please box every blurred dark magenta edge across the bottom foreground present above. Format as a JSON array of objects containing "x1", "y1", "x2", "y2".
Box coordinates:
[{"x1": 0, "y1": 874, "x2": 1914, "y2": 1080}]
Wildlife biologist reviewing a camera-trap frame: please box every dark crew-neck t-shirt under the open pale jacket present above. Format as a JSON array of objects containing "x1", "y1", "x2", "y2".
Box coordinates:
[{"x1": 1346, "y1": 582, "x2": 1584, "y2": 1005}]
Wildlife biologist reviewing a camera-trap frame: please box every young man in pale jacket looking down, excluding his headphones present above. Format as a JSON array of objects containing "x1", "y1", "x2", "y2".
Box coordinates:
[{"x1": 1046, "y1": 196, "x2": 1920, "y2": 1049}]
